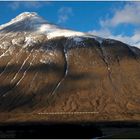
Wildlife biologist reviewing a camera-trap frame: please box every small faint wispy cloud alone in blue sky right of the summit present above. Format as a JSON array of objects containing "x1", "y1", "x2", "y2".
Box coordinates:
[{"x1": 58, "y1": 7, "x2": 73, "y2": 23}]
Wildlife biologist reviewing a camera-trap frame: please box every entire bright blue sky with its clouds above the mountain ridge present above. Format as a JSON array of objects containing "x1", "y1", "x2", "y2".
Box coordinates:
[{"x1": 0, "y1": 1, "x2": 140, "y2": 46}]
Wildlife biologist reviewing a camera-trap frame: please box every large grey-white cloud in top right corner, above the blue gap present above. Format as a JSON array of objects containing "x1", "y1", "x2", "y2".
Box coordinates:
[{"x1": 100, "y1": 2, "x2": 140, "y2": 27}]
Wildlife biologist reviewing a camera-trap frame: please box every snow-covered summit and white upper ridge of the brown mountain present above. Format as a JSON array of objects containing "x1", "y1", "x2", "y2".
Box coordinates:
[{"x1": 0, "y1": 12, "x2": 102, "y2": 42}]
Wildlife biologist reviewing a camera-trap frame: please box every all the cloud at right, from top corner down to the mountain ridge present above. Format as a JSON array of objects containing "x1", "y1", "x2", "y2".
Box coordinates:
[{"x1": 89, "y1": 2, "x2": 140, "y2": 48}]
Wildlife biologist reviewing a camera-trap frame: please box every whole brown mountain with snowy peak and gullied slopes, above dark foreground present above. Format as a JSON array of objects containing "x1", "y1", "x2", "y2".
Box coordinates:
[{"x1": 0, "y1": 13, "x2": 140, "y2": 122}]
